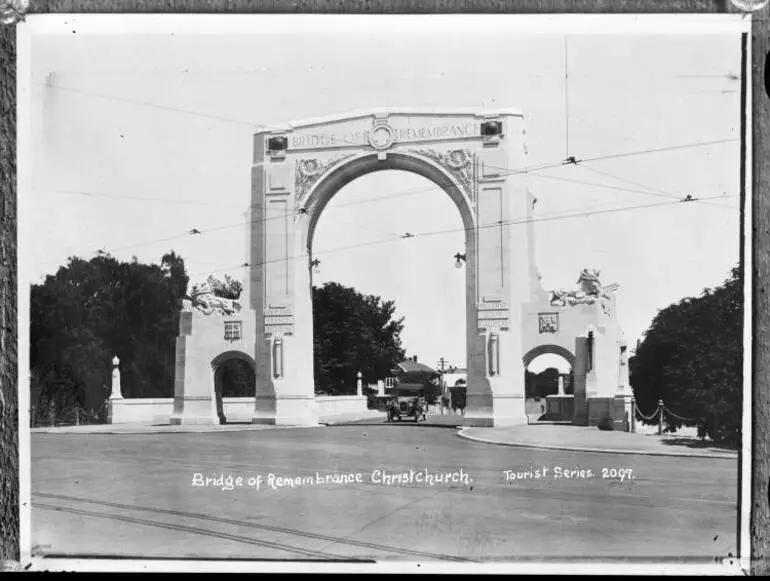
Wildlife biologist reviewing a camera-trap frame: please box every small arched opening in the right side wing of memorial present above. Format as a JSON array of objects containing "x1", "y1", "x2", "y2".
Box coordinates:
[{"x1": 523, "y1": 345, "x2": 575, "y2": 422}]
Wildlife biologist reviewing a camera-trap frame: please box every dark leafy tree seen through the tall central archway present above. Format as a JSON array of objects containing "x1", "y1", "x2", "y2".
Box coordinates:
[{"x1": 313, "y1": 283, "x2": 405, "y2": 395}]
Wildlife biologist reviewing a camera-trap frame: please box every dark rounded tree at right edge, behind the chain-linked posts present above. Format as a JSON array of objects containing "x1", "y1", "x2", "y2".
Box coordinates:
[{"x1": 629, "y1": 267, "x2": 743, "y2": 443}]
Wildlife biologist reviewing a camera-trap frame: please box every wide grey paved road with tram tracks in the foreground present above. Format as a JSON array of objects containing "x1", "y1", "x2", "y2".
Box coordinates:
[{"x1": 32, "y1": 424, "x2": 737, "y2": 561}]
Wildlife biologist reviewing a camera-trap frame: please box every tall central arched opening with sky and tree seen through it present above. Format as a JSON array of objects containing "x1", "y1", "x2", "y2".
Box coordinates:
[{"x1": 304, "y1": 153, "x2": 473, "y2": 408}]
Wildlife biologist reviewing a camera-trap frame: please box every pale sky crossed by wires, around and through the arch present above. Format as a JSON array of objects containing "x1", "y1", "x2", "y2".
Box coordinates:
[{"x1": 21, "y1": 17, "x2": 740, "y2": 371}]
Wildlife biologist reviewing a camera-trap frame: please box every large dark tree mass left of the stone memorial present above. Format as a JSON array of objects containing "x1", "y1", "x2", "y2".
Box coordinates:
[{"x1": 30, "y1": 252, "x2": 188, "y2": 409}]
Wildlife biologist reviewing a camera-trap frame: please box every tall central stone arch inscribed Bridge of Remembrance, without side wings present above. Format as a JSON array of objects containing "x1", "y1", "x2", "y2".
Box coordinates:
[{"x1": 247, "y1": 111, "x2": 531, "y2": 426}]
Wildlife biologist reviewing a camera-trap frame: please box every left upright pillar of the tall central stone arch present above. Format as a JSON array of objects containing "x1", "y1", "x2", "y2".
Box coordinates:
[{"x1": 249, "y1": 129, "x2": 318, "y2": 426}]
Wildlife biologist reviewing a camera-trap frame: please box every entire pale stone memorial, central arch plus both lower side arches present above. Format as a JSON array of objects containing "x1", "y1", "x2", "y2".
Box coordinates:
[{"x1": 171, "y1": 110, "x2": 632, "y2": 426}]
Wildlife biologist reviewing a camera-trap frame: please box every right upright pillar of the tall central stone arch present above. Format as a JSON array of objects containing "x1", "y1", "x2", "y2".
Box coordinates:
[{"x1": 464, "y1": 115, "x2": 534, "y2": 427}]
